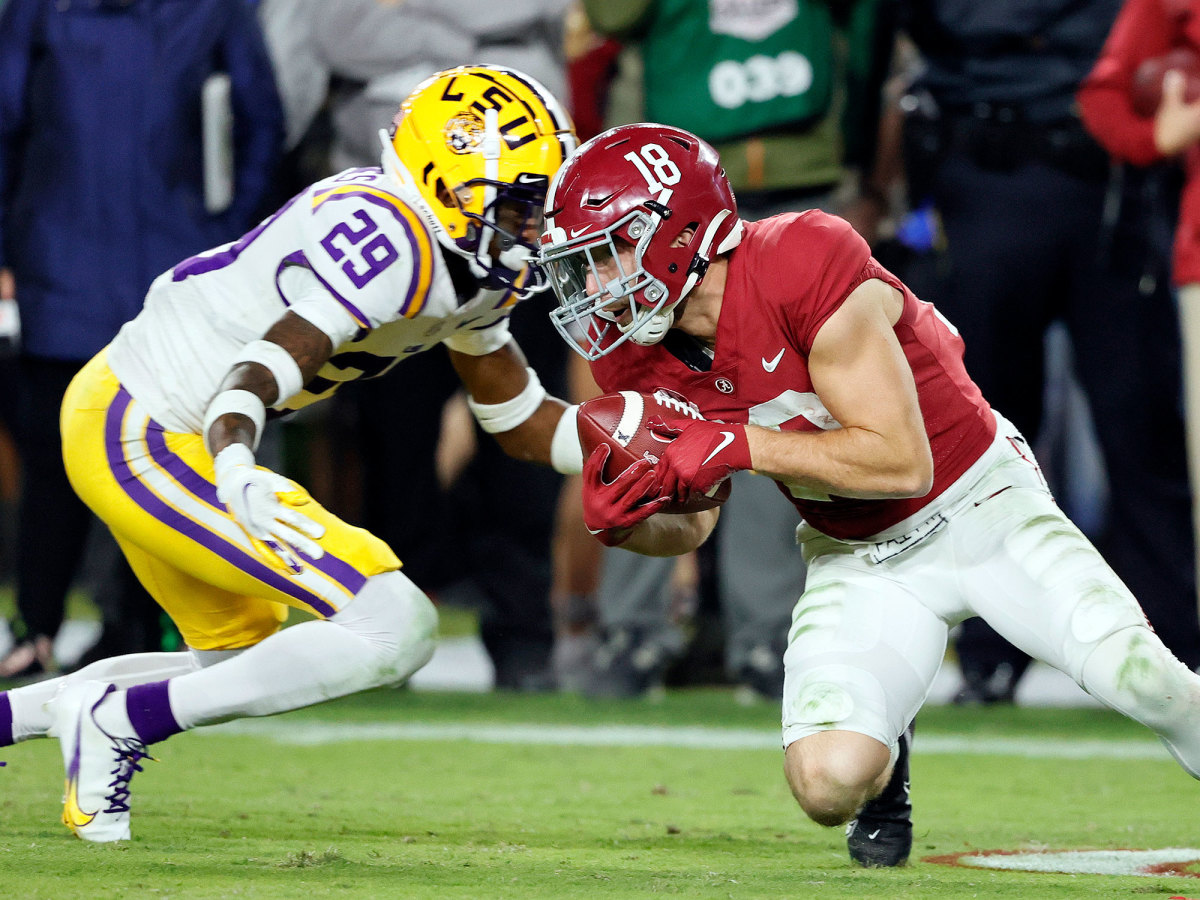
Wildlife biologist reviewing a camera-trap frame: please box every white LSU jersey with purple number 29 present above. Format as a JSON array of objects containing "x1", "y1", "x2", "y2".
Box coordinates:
[{"x1": 108, "y1": 168, "x2": 517, "y2": 433}]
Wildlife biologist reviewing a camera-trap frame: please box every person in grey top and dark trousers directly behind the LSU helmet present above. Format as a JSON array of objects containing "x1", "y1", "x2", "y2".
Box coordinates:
[{"x1": 312, "y1": 0, "x2": 568, "y2": 690}]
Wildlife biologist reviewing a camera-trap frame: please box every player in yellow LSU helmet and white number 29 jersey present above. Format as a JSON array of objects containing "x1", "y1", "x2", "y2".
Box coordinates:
[{"x1": 0, "y1": 66, "x2": 582, "y2": 841}]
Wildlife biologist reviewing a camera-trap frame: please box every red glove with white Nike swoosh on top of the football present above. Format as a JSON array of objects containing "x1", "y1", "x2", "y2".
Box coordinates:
[{"x1": 647, "y1": 419, "x2": 751, "y2": 500}]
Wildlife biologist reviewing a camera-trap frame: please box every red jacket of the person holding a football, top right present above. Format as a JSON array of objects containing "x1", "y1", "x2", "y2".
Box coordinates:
[{"x1": 1079, "y1": 0, "x2": 1200, "y2": 284}]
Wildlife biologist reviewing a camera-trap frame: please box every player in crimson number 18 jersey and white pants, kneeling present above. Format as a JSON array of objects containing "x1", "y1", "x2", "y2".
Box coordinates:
[{"x1": 540, "y1": 124, "x2": 1200, "y2": 865}]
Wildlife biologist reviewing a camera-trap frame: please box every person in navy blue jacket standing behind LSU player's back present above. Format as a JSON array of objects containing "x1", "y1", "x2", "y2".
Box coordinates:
[{"x1": 0, "y1": 0, "x2": 283, "y2": 678}]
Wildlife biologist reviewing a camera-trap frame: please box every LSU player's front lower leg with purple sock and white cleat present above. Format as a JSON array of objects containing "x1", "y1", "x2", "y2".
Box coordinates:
[{"x1": 53, "y1": 571, "x2": 437, "y2": 842}]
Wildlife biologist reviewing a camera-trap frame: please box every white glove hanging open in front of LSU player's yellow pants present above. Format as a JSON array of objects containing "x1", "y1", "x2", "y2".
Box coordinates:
[{"x1": 212, "y1": 444, "x2": 325, "y2": 571}]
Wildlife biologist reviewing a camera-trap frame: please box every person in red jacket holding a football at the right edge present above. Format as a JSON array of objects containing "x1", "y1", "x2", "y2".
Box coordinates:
[{"x1": 1079, "y1": 0, "x2": 1200, "y2": 643}]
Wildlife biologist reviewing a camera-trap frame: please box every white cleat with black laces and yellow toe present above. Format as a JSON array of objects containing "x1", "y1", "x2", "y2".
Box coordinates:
[{"x1": 53, "y1": 682, "x2": 152, "y2": 844}]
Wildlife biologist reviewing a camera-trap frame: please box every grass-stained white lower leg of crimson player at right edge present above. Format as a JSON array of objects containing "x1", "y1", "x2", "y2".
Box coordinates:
[{"x1": 1080, "y1": 625, "x2": 1200, "y2": 779}]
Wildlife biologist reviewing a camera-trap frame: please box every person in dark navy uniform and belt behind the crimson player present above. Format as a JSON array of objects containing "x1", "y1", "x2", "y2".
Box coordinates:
[{"x1": 902, "y1": 0, "x2": 1200, "y2": 703}]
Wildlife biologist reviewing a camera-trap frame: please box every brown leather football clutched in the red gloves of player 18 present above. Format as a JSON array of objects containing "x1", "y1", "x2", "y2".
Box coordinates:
[{"x1": 576, "y1": 390, "x2": 731, "y2": 515}]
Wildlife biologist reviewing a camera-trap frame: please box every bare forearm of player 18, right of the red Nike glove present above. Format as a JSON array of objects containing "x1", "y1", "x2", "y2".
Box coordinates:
[{"x1": 746, "y1": 426, "x2": 934, "y2": 499}]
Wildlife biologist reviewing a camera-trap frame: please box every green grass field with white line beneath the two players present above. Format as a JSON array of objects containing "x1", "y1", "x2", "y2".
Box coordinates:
[{"x1": 0, "y1": 690, "x2": 1200, "y2": 900}]
